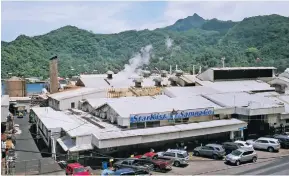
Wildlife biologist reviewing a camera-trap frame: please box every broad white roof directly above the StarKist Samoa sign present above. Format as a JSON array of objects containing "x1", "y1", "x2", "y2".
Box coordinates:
[{"x1": 107, "y1": 96, "x2": 221, "y2": 117}]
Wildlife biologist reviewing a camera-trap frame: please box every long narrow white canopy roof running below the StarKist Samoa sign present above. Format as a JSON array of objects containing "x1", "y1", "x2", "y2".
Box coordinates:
[{"x1": 93, "y1": 119, "x2": 246, "y2": 140}]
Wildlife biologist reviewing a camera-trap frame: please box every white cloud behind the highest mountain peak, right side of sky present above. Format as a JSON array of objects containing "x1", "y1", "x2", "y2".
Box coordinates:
[{"x1": 164, "y1": 1, "x2": 289, "y2": 23}]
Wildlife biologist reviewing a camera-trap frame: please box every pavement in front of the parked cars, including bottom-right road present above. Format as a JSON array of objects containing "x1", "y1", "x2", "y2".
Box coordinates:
[{"x1": 153, "y1": 149, "x2": 289, "y2": 175}]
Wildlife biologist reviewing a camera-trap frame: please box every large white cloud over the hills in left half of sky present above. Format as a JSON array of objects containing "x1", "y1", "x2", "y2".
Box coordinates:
[{"x1": 2, "y1": 2, "x2": 132, "y2": 33}]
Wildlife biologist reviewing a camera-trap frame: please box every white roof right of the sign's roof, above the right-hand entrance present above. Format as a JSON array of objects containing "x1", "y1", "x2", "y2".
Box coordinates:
[{"x1": 203, "y1": 92, "x2": 282, "y2": 109}]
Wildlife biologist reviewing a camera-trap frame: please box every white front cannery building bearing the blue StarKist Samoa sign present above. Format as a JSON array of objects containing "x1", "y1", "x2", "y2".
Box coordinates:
[{"x1": 32, "y1": 96, "x2": 247, "y2": 157}]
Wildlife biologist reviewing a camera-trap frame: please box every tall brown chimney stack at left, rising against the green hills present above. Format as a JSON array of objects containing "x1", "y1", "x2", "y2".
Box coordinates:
[{"x1": 49, "y1": 56, "x2": 59, "y2": 93}]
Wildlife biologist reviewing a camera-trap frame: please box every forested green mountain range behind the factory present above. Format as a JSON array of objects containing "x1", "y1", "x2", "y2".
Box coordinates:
[{"x1": 1, "y1": 14, "x2": 289, "y2": 78}]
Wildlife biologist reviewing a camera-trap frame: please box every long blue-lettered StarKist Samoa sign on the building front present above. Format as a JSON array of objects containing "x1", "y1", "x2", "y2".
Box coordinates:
[{"x1": 130, "y1": 108, "x2": 214, "y2": 123}]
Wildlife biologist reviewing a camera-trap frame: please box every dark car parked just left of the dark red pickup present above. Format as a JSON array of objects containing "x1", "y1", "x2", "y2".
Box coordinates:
[{"x1": 113, "y1": 158, "x2": 155, "y2": 171}]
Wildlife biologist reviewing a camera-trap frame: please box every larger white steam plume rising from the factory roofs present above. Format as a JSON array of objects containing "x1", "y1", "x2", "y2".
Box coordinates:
[{"x1": 114, "y1": 45, "x2": 153, "y2": 79}]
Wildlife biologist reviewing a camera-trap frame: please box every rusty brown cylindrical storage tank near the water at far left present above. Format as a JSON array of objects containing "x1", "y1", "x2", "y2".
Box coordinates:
[{"x1": 5, "y1": 76, "x2": 27, "y2": 97}]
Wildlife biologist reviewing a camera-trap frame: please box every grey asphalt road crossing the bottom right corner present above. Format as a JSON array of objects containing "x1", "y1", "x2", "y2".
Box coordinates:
[{"x1": 205, "y1": 156, "x2": 289, "y2": 175}]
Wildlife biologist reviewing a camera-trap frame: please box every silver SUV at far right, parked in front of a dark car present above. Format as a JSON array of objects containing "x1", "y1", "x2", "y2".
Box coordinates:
[{"x1": 253, "y1": 137, "x2": 280, "y2": 152}]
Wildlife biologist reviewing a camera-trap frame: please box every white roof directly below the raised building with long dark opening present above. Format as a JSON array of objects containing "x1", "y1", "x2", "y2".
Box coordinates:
[{"x1": 199, "y1": 80, "x2": 275, "y2": 92}]
